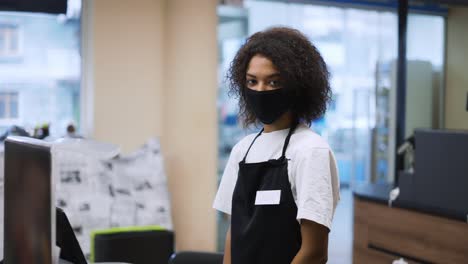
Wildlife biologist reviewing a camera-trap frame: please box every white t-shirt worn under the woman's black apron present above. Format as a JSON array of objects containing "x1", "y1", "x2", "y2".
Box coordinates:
[{"x1": 213, "y1": 124, "x2": 340, "y2": 229}]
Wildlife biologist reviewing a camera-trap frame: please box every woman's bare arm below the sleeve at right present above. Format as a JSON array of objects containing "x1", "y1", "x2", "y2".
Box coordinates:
[{"x1": 290, "y1": 219, "x2": 329, "y2": 264}]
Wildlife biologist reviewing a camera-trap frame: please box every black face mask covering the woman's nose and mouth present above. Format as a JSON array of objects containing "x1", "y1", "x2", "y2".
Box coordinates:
[{"x1": 245, "y1": 88, "x2": 292, "y2": 125}]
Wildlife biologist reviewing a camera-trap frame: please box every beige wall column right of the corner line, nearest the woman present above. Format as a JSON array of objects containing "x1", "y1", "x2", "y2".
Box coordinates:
[{"x1": 163, "y1": 0, "x2": 218, "y2": 250}]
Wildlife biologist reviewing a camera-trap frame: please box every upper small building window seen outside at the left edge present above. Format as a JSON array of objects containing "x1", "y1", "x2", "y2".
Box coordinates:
[{"x1": 0, "y1": 24, "x2": 20, "y2": 57}]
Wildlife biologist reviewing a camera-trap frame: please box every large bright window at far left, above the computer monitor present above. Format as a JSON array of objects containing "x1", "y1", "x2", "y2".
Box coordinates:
[{"x1": 0, "y1": 0, "x2": 81, "y2": 137}]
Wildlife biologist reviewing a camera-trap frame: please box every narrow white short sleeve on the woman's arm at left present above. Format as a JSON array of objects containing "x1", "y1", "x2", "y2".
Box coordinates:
[{"x1": 213, "y1": 145, "x2": 239, "y2": 215}]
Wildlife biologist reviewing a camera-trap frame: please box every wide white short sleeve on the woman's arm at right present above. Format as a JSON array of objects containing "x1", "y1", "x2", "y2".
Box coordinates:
[{"x1": 293, "y1": 148, "x2": 339, "y2": 229}]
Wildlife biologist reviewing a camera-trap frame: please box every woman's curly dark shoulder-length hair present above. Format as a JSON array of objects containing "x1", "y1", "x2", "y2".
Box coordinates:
[{"x1": 226, "y1": 27, "x2": 332, "y2": 127}]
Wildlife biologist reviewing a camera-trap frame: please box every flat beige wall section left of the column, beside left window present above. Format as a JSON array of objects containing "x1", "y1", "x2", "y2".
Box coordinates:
[{"x1": 93, "y1": 0, "x2": 164, "y2": 151}]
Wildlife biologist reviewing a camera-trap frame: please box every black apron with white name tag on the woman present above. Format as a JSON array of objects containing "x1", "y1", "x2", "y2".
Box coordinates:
[{"x1": 231, "y1": 124, "x2": 301, "y2": 264}]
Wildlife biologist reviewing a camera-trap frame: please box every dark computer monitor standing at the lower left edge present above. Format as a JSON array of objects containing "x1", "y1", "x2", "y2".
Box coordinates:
[{"x1": 4, "y1": 137, "x2": 56, "y2": 264}]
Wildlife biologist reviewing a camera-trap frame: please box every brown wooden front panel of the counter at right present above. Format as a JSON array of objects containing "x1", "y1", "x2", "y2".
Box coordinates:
[{"x1": 353, "y1": 198, "x2": 468, "y2": 263}]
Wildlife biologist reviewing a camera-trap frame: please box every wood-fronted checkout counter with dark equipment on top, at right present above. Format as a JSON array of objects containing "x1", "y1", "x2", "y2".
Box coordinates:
[{"x1": 353, "y1": 130, "x2": 468, "y2": 263}]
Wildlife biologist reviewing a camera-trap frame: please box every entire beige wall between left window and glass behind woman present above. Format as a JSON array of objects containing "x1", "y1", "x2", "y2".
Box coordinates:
[{"x1": 91, "y1": 0, "x2": 217, "y2": 250}]
